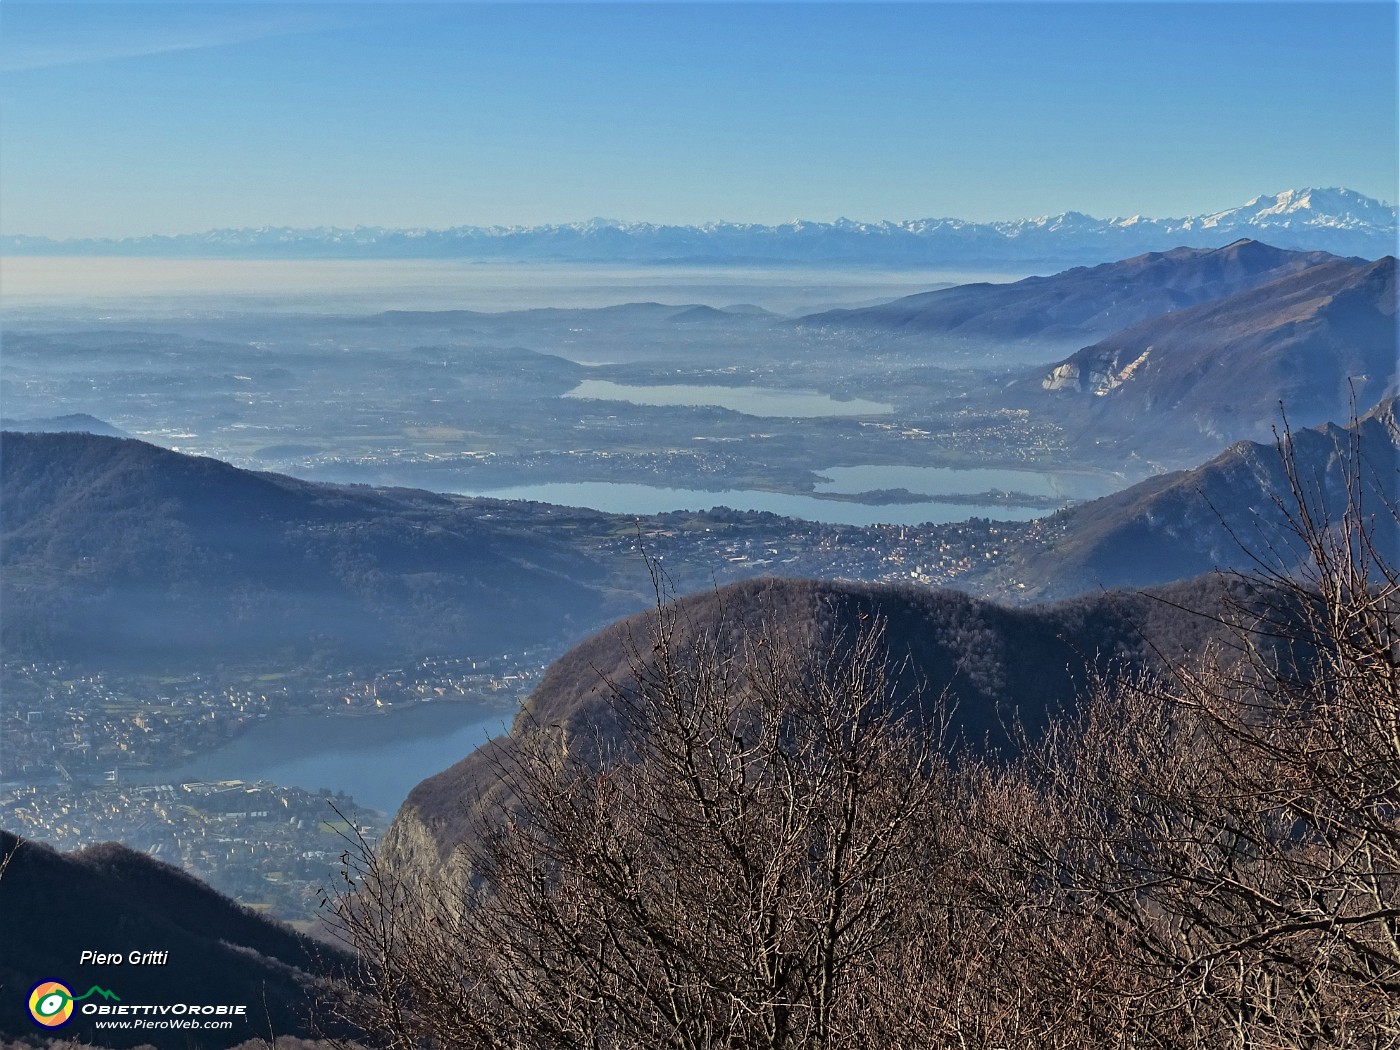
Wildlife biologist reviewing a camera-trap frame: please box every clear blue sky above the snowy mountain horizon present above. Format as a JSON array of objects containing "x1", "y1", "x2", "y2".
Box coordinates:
[{"x1": 0, "y1": 0, "x2": 1400, "y2": 237}]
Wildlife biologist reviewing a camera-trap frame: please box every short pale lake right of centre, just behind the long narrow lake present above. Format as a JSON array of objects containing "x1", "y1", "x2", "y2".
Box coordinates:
[{"x1": 816, "y1": 466, "x2": 1127, "y2": 500}]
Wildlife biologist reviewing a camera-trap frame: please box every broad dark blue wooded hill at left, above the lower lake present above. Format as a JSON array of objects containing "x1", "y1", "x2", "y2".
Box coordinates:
[{"x1": 0, "y1": 433, "x2": 636, "y2": 665}]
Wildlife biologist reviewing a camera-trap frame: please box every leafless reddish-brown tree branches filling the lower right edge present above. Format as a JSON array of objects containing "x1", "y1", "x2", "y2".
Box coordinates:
[{"x1": 984, "y1": 406, "x2": 1400, "y2": 1047}]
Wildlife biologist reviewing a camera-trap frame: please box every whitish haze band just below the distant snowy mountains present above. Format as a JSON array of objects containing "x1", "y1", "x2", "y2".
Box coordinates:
[{"x1": 0, "y1": 256, "x2": 1026, "y2": 321}]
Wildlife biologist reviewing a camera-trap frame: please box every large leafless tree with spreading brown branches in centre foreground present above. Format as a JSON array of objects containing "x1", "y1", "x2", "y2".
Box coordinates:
[{"x1": 327, "y1": 588, "x2": 948, "y2": 1047}]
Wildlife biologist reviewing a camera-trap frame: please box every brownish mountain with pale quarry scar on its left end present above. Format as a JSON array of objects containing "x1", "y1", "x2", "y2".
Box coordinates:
[{"x1": 1036, "y1": 258, "x2": 1397, "y2": 447}]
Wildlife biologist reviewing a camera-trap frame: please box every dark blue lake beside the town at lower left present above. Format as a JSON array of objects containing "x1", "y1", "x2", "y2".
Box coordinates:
[{"x1": 132, "y1": 703, "x2": 514, "y2": 816}]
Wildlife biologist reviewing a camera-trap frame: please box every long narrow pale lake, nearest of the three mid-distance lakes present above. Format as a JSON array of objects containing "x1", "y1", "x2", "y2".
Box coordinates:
[{"x1": 458, "y1": 482, "x2": 1050, "y2": 525}]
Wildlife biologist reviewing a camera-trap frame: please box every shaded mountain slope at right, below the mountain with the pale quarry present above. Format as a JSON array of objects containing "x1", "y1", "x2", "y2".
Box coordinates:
[{"x1": 990, "y1": 396, "x2": 1400, "y2": 599}]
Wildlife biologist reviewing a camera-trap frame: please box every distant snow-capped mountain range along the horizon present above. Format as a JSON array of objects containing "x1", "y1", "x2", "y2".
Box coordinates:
[{"x1": 0, "y1": 189, "x2": 1397, "y2": 266}]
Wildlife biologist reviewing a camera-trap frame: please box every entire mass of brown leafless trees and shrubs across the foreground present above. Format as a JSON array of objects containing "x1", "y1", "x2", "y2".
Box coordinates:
[{"x1": 336, "y1": 422, "x2": 1400, "y2": 1050}]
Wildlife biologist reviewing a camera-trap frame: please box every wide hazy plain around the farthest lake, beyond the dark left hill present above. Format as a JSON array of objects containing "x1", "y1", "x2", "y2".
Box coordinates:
[{"x1": 0, "y1": 258, "x2": 1124, "y2": 525}]
